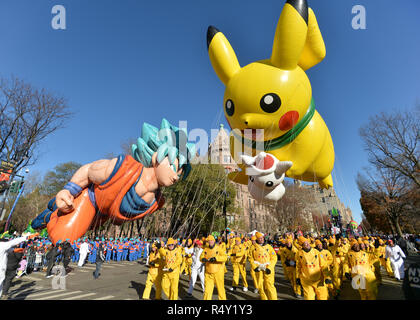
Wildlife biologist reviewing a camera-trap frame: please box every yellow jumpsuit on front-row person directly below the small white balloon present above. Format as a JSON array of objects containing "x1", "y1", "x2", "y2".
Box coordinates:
[{"x1": 249, "y1": 243, "x2": 277, "y2": 300}]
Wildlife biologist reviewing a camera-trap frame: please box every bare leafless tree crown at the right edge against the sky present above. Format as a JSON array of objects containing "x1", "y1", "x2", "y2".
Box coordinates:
[{"x1": 359, "y1": 104, "x2": 420, "y2": 188}]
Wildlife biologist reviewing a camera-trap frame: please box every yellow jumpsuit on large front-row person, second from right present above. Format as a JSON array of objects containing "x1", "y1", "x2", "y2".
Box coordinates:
[{"x1": 296, "y1": 248, "x2": 328, "y2": 300}]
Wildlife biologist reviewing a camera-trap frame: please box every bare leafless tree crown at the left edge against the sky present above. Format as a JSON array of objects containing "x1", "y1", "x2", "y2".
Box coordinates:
[{"x1": 0, "y1": 77, "x2": 71, "y2": 172}]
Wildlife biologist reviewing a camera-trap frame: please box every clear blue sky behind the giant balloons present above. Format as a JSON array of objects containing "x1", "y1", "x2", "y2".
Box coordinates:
[{"x1": 0, "y1": 0, "x2": 420, "y2": 221}]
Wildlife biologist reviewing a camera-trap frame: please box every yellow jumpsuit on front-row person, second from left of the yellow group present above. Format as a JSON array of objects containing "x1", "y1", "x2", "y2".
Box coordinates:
[{"x1": 159, "y1": 248, "x2": 182, "y2": 300}]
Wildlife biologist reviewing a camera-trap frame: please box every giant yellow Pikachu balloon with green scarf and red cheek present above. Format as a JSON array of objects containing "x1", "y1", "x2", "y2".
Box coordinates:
[{"x1": 207, "y1": 0, "x2": 334, "y2": 188}]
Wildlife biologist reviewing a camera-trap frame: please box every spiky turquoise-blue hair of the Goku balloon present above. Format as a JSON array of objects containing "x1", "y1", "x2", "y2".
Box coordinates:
[{"x1": 131, "y1": 119, "x2": 195, "y2": 179}]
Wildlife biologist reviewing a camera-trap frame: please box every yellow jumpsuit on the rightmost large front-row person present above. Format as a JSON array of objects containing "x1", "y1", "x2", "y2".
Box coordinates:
[{"x1": 343, "y1": 250, "x2": 378, "y2": 300}]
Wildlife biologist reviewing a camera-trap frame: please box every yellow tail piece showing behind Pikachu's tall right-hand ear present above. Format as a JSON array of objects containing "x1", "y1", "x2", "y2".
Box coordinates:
[{"x1": 298, "y1": 8, "x2": 326, "y2": 70}]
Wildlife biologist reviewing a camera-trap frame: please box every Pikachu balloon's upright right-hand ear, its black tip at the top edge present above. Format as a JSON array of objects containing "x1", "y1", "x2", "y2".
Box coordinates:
[{"x1": 270, "y1": 0, "x2": 308, "y2": 70}]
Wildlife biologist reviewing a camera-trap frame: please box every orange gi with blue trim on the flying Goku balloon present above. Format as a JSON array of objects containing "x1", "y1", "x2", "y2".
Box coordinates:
[{"x1": 32, "y1": 155, "x2": 164, "y2": 243}]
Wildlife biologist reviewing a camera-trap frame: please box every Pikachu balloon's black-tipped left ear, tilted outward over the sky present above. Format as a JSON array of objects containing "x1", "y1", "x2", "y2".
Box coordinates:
[{"x1": 207, "y1": 26, "x2": 241, "y2": 85}]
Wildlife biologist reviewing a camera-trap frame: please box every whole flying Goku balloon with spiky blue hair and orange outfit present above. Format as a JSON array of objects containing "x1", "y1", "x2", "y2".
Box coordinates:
[{"x1": 32, "y1": 119, "x2": 195, "y2": 243}]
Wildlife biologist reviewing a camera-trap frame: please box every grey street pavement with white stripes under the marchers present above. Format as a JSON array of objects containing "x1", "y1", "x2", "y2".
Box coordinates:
[{"x1": 4, "y1": 255, "x2": 420, "y2": 300}]
